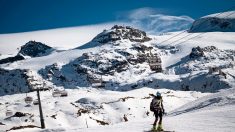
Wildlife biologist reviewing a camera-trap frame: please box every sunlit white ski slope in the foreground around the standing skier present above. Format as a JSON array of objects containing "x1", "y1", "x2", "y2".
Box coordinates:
[{"x1": 1, "y1": 88, "x2": 235, "y2": 132}]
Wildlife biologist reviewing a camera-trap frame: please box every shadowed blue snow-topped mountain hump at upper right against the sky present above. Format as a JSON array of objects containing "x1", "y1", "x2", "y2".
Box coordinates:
[{"x1": 189, "y1": 11, "x2": 235, "y2": 33}]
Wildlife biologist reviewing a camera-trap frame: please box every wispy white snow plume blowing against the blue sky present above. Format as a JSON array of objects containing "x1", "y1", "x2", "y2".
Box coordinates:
[{"x1": 119, "y1": 8, "x2": 194, "y2": 34}]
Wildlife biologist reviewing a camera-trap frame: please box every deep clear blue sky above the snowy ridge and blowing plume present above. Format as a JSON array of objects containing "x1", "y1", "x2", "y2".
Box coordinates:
[{"x1": 0, "y1": 0, "x2": 235, "y2": 34}]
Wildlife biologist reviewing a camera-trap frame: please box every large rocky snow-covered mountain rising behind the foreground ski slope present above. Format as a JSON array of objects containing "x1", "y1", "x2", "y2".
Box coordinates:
[{"x1": 2, "y1": 26, "x2": 235, "y2": 94}]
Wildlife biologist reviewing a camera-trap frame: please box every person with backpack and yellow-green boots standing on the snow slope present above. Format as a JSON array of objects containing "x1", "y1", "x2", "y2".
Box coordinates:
[{"x1": 150, "y1": 92, "x2": 165, "y2": 131}]
